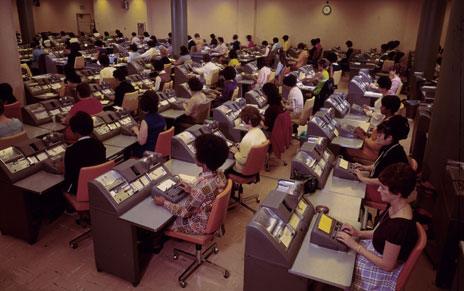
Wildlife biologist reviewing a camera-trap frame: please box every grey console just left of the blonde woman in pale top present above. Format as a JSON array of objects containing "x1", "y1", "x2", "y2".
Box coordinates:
[{"x1": 213, "y1": 98, "x2": 246, "y2": 142}]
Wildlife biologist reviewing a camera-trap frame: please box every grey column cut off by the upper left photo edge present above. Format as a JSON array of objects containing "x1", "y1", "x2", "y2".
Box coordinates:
[{"x1": 0, "y1": 1, "x2": 24, "y2": 104}]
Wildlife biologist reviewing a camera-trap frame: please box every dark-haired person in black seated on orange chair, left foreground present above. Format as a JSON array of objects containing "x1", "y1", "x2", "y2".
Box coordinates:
[{"x1": 64, "y1": 111, "x2": 106, "y2": 195}]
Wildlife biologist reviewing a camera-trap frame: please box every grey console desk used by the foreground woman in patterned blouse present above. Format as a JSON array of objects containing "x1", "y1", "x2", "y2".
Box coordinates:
[{"x1": 89, "y1": 157, "x2": 185, "y2": 286}]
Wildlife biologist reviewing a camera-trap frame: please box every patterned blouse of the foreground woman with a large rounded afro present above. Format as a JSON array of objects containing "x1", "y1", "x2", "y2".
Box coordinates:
[{"x1": 164, "y1": 171, "x2": 227, "y2": 234}]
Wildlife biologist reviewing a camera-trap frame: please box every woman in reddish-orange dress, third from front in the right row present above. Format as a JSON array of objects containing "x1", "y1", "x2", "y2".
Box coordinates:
[{"x1": 346, "y1": 95, "x2": 401, "y2": 161}]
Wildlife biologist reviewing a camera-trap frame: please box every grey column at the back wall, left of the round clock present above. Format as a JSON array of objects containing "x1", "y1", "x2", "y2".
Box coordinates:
[{"x1": 171, "y1": 0, "x2": 187, "y2": 56}]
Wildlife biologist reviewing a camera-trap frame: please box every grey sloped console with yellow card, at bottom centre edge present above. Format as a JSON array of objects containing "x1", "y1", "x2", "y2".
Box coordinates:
[{"x1": 243, "y1": 186, "x2": 315, "y2": 291}]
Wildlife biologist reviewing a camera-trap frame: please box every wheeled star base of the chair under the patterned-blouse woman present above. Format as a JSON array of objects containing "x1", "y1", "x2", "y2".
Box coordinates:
[{"x1": 173, "y1": 243, "x2": 230, "y2": 288}]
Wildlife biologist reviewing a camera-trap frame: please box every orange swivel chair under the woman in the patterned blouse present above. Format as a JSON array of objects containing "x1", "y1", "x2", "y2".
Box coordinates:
[{"x1": 165, "y1": 179, "x2": 232, "y2": 288}]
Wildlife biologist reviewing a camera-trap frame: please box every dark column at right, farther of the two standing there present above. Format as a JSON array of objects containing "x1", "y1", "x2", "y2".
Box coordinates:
[{"x1": 414, "y1": 0, "x2": 447, "y2": 79}]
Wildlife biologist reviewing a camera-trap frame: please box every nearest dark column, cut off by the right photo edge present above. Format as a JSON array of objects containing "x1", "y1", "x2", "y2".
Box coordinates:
[{"x1": 423, "y1": 0, "x2": 464, "y2": 189}]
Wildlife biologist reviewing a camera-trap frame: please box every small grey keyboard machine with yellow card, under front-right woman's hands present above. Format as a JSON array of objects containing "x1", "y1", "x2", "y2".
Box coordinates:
[{"x1": 310, "y1": 213, "x2": 348, "y2": 252}]
